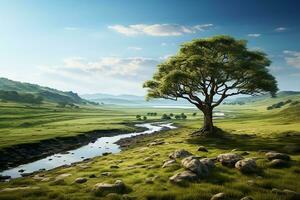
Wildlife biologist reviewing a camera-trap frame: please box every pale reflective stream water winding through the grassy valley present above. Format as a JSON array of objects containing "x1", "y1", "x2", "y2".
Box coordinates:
[{"x1": 0, "y1": 123, "x2": 176, "y2": 178}]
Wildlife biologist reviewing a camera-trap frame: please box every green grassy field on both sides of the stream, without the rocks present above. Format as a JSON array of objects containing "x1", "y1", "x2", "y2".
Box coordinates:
[{"x1": 0, "y1": 97, "x2": 300, "y2": 200}]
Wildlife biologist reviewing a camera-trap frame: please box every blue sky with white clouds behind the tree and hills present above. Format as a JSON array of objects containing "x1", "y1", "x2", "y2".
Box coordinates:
[{"x1": 0, "y1": 0, "x2": 300, "y2": 95}]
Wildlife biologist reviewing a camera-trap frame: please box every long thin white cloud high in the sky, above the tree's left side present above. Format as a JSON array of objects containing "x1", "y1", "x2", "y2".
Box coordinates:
[{"x1": 108, "y1": 24, "x2": 213, "y2": 36}]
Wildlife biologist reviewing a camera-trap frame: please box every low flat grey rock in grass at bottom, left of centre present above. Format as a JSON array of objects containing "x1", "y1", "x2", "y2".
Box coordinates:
[{"x1": 94, "y1": 180, "x2": 126, "y2": 196}]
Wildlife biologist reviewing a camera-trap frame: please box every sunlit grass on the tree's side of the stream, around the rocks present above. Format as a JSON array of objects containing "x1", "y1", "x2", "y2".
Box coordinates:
[{"x1": 0, "y1": 95, "x2": 300, "y2": 200}]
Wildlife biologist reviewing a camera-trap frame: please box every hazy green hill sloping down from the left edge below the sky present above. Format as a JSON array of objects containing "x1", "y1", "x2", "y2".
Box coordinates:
[{"x1": 0, "y1": 78, "x2": 91, "y2": 104}]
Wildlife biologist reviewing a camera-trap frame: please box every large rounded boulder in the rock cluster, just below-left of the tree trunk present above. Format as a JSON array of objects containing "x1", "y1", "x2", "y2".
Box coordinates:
[{"x1": 181, "y1": 156, "x2": 208, "y2": 176}]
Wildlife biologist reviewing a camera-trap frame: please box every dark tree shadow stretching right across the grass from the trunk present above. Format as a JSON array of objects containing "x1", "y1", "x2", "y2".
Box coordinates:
[{"x1": 187, "y1": 128, "x2": 300, "y2": 154}]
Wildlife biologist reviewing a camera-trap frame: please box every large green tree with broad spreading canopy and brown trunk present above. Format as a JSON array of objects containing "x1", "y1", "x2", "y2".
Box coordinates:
[{"x1": 144, "y1": 35, "x2": 278, "y2": 134}]
